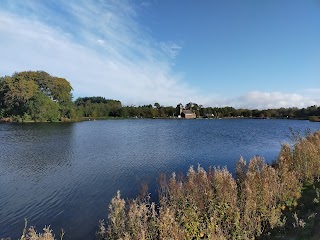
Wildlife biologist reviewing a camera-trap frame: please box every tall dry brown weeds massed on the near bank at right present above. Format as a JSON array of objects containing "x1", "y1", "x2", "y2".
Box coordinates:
[{"x1": 97, "y1": 132, "x2": 320, "y2": 240}]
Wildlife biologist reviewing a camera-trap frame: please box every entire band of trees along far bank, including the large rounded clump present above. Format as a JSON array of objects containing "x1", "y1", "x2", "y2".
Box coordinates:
[{"x1": 0, "y1": 71, "x2": 320, "y2": 122}]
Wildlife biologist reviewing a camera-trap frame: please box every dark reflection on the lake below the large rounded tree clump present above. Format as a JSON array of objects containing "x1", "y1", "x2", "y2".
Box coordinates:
[{"x1": 0, "y1": 123, "x2": 74, "y2": 174}]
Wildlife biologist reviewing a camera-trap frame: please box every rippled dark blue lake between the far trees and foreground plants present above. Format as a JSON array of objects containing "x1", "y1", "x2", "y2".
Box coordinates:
[{"x1": 0, "y1": 119, "x2": 320, "y2": 239}]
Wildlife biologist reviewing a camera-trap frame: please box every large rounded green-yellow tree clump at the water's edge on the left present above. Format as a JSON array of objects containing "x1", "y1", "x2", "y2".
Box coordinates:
[{"x1": 0, "y1": 71, "x2": 72, "y2": 121}]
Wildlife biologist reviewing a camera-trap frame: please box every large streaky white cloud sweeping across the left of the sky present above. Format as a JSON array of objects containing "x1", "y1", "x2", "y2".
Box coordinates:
[{"x1": 0, "y1": 1, "x2": 200, "y2": 104}]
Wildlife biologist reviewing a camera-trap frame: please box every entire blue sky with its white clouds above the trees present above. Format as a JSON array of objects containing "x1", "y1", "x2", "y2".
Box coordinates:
[{"x1": 0, "y1": 0, "x2": 320, "y2": 109}]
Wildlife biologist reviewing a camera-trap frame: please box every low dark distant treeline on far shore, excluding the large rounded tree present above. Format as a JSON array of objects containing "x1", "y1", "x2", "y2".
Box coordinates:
[{"x1": 71, "y1": 101, "x2": 320, "y2": 119}]
